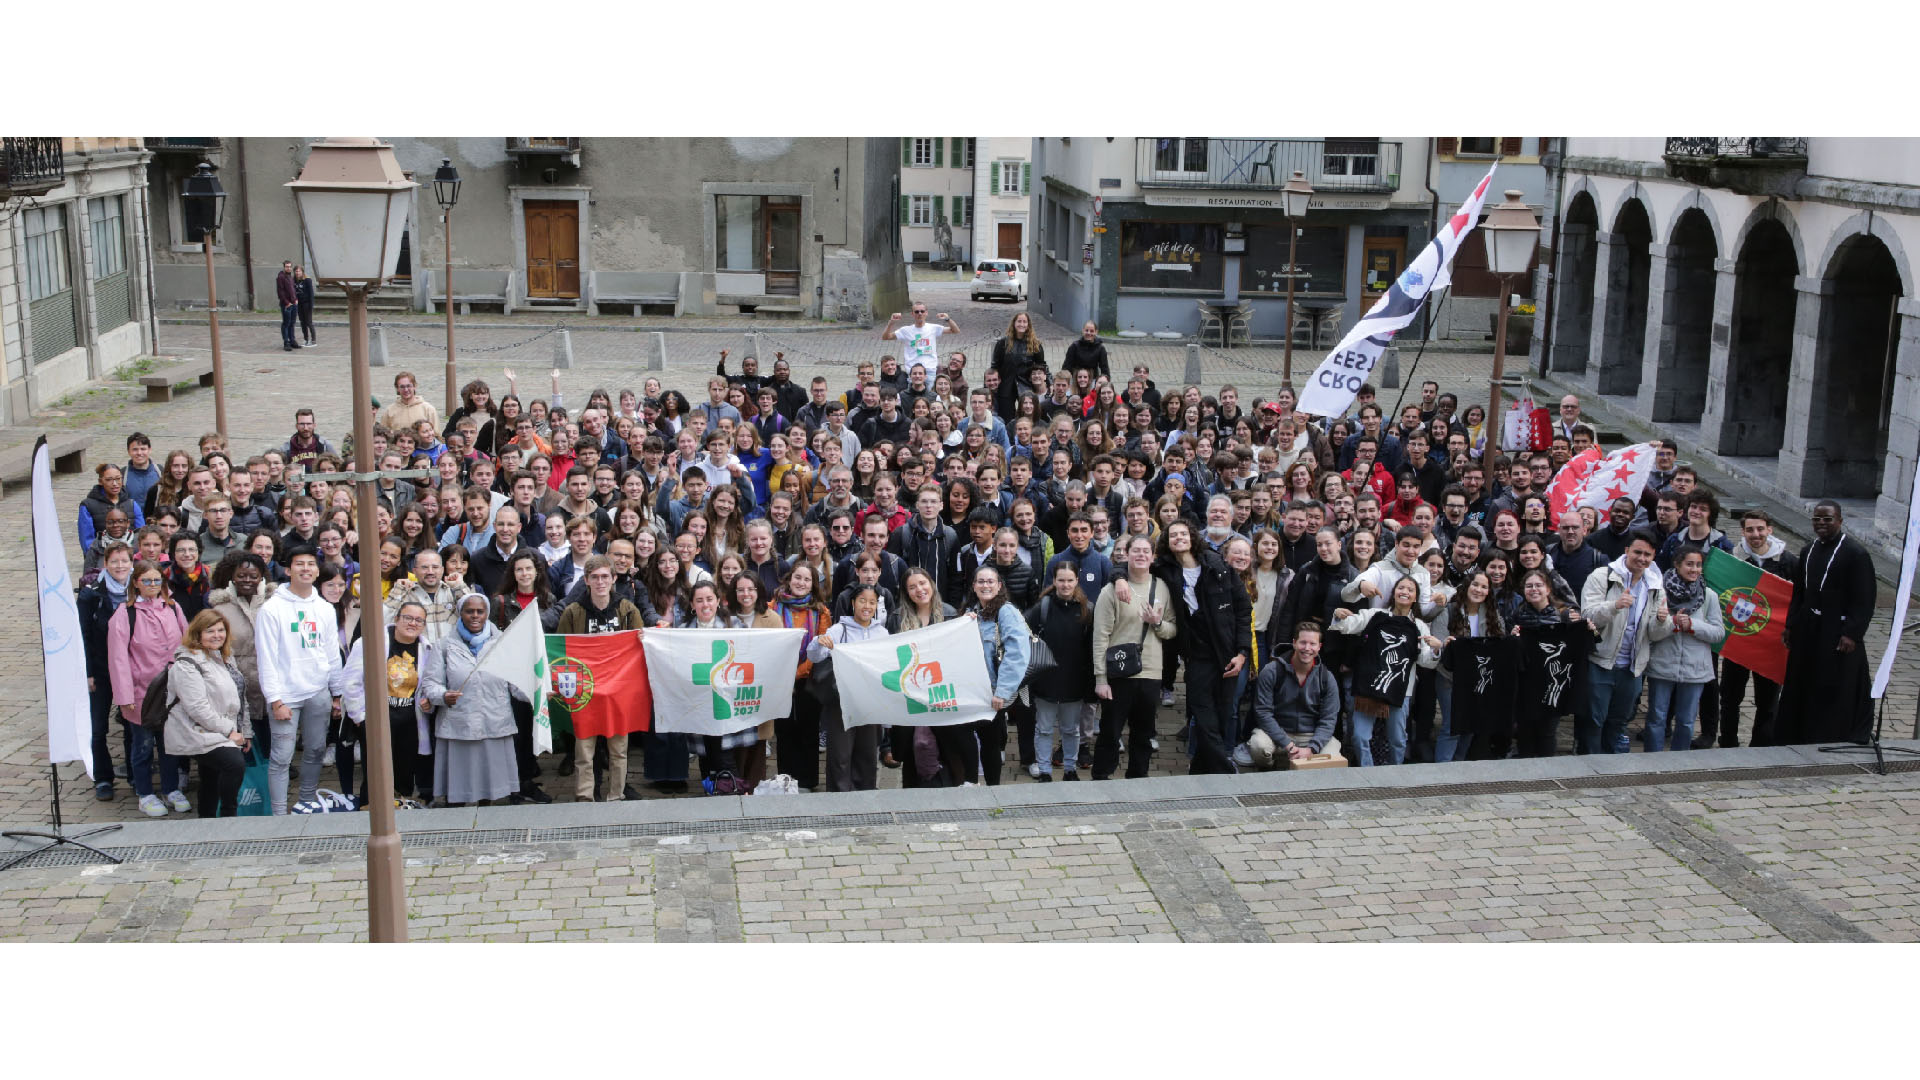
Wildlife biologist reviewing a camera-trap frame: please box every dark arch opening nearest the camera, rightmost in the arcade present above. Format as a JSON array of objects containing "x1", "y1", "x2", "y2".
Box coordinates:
[{"x1": 1799, "y1": 233, "x2": 1907, "y2": 498}]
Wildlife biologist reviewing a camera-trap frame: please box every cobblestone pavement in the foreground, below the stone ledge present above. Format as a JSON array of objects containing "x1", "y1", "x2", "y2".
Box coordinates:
[{"x1": 0, "y1": 773, "x2": 1920, "y2": 942}]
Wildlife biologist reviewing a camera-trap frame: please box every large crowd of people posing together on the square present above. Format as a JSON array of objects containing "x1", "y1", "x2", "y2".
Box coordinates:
[{"x1": 77, "y1": 304, "x2": 1874, "y2": 817}]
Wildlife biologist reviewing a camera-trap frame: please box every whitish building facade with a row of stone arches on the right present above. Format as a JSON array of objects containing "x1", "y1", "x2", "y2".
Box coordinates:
[{"x1": 1534, "y1": 138, "x2": 1920, "y2": 548}]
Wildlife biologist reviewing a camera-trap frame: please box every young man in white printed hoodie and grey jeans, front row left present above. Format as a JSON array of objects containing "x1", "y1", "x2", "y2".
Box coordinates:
[{"x1": 253, "y1": 546, "x2": 340, "y2": 815}]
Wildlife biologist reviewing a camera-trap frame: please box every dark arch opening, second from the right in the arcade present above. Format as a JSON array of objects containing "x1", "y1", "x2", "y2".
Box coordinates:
[{"x1": 1707, "y1": 219, "x2": 1803, "y2": 455}]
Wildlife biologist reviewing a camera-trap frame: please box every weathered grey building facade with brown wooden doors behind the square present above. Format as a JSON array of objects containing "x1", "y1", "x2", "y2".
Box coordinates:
[{"x1": 152, "y1": 136, "x2": 906, "y2": 319}]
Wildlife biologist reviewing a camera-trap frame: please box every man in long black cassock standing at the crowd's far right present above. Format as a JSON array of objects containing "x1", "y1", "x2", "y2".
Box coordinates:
[{"x1": 1778, "y1": 500, "x2": 1876, "y2": 746}]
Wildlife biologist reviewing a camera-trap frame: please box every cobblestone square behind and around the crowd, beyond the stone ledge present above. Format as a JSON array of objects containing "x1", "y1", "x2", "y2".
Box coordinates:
[{"x1": 0, "y1": 284, "x2": 1920, "y2": 824}]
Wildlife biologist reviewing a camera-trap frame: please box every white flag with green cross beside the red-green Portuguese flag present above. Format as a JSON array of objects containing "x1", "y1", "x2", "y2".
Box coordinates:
[{"x1": 641, "y1": 628, "x2": 806, "y2": 736}]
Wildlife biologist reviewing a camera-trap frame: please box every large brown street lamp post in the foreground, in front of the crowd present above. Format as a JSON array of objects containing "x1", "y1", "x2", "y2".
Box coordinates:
[{"x1": 286, "y1": 138, "x2": 415, "y2": 942}]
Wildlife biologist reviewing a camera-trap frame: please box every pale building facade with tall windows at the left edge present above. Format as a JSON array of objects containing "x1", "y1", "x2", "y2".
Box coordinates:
[{"x1": 0, "y1": 136, "x2": 154, "y2": 425}]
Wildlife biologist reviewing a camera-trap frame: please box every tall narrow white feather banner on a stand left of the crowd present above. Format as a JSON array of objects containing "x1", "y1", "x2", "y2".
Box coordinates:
[{"x1": 33, "y1": 434, "x2": 94, "y2": 776}]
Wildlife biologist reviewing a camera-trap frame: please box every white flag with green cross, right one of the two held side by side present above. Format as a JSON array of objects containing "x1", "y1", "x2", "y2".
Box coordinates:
[{"x1": 833, "y1": 619, "x2": 995, "y2": 728}]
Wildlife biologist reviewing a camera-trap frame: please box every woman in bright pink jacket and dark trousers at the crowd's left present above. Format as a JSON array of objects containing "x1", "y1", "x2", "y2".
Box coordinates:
[{"x1": 108, "y1": 559, "x2": 194, "y2": 817}]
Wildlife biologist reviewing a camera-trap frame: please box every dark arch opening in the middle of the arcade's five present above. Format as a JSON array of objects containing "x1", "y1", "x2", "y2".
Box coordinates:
[{"x1": 1644, "y1": 206, "x2": 1720, "y2": 423}]
